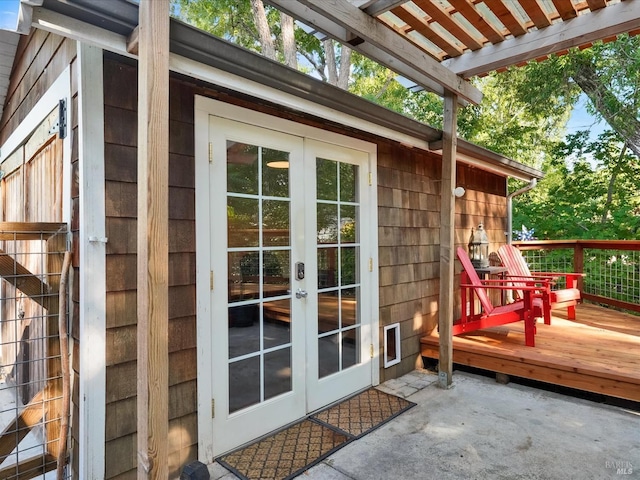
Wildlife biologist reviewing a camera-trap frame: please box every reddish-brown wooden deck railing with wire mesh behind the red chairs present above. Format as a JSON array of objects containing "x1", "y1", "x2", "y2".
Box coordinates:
[{"x1": 514, "y1": 240, "x2": 640, "y2": 313}]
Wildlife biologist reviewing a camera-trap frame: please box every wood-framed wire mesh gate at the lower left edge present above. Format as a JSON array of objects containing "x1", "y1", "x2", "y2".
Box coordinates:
[{"x1": 0, "y1": 224, "x2": 66, "y2": 480}]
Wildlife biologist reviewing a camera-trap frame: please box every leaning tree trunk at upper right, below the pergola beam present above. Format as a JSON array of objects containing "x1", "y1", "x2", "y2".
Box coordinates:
[{"x1": 573, "y1": 62, "x2": 640, "y2": 157}]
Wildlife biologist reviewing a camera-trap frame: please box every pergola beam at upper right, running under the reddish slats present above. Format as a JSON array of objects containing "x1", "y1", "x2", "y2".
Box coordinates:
[{"x1": 442, "y1": 2, "x2": 640, "y2": 78}]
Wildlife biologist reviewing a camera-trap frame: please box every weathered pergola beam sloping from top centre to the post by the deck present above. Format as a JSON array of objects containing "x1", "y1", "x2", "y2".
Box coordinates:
[{"x1": 266, "y1": 0, "x2": 482, "y2": 104}]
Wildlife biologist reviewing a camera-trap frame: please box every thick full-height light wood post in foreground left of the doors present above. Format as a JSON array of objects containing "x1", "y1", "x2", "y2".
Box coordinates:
[{"x1": 137, "y1": 0, "x2": 169, "y2": 480}]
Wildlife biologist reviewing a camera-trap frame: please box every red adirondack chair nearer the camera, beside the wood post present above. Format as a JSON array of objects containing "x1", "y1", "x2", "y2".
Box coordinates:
[{"x1": 452, "y1": 247, "x2": 549, "y2": 347}]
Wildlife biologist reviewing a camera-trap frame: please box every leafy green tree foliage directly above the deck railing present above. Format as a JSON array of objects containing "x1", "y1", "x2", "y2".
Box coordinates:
[{"x1": 514, "y1": 130, "x2": 640, "y2": 239}]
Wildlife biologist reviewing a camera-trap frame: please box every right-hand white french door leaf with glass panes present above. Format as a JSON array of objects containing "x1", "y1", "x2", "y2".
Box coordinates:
[{"x1": 304, "y1": 140, "x2": 374, "y2": 411}]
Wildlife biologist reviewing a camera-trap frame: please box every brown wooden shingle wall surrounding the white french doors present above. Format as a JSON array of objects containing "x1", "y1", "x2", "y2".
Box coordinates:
[{"x1": 104, "y1": 55, "x2": 506, "y2": 479}]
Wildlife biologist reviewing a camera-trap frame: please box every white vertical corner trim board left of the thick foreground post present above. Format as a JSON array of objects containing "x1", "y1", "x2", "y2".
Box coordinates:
[{"x1": 77, "y1": 42, "x2": 107, "y2": 480}]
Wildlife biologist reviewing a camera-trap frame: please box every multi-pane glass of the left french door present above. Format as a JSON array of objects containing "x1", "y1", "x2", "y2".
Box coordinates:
[{"x1": 227, "y1": 141, "x2": 292, "y2": 413}]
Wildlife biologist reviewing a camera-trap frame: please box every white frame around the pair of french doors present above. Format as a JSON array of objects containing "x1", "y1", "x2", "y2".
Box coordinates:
[{"x1": 194, "y1": 95, "x2": 379, "y2": 463}]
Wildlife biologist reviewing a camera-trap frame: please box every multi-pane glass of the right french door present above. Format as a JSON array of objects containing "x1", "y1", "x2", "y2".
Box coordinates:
[{"x1": 316, "y1": 158, "x2": 362, "y2": 378}]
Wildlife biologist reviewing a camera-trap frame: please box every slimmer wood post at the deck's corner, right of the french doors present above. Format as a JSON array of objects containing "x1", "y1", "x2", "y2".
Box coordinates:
[{"x1": 438, "y1": 91, "x2": 464, "y2": 388}]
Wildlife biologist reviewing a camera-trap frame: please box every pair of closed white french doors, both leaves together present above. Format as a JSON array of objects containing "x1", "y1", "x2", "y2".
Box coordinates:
[{"x1": 198, "y1": 116, "x2": 377, "y2": 455}]
